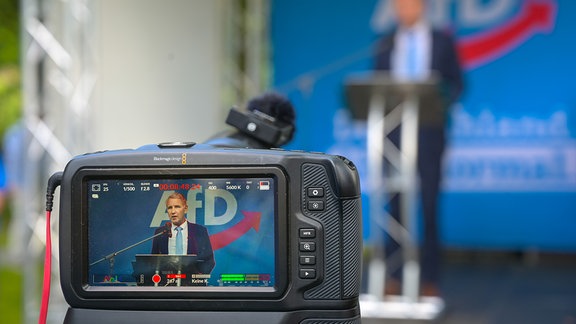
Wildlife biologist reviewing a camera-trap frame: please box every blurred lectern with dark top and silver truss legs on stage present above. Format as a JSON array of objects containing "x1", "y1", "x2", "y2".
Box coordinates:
[{"x1": 345, "y1": 73, "x2": 444, "y2": 323}]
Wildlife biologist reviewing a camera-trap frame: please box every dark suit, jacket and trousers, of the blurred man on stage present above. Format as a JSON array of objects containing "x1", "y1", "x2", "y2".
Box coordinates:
[{"x1": 375, "y1": 28, "x2": 463, "y2": 294}]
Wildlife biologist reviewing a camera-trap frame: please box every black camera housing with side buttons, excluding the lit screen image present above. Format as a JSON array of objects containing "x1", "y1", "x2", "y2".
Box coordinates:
[{"x1": 60, "y1": 143, "x2": 362, "y2": 323}]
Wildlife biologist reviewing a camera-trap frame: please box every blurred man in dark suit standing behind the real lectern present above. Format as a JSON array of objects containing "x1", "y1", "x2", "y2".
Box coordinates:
[{"x1": 375, "y1": 0, "x2": 463, "y2": 296}]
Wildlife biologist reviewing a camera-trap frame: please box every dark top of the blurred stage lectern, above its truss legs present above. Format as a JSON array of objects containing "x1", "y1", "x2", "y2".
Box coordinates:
[{"x1": 345, "y1": 72, "x2": 445, "y2": 125}]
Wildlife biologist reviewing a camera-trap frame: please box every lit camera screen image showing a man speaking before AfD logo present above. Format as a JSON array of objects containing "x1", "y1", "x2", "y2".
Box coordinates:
[{"x1": 84, "y1": 175, "x2": 278, "y2": 292}]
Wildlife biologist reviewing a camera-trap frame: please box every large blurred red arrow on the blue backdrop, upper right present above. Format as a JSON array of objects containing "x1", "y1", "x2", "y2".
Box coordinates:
[{"x1": 458, "y1": 0, "x2": 556, "y2": 68}]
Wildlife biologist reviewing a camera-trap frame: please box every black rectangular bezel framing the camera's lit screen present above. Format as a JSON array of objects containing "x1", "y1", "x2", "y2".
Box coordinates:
[{"x1": 69, "y1": 166, "x2": 290, "y2": 300}]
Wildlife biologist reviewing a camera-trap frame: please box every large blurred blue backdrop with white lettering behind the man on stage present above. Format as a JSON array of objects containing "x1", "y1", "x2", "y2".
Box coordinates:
[{"x1": 271, "y1": 0, "x2": 576, "y2": 251}]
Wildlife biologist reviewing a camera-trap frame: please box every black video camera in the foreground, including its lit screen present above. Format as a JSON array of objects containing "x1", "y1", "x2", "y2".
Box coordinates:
[{"x1": 60, "y1": 142, "x2": 362, "y2": 323}]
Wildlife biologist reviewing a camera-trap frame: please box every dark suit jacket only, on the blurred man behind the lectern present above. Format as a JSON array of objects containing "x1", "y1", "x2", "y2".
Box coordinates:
[{"x1": 375, "y1": 29, "x2": 464, "y2": 104}]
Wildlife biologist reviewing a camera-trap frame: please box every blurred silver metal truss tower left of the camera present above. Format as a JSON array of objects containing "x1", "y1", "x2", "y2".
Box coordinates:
[{"x1": 18, "y1": 0, "x2": 95, "y2": 323}]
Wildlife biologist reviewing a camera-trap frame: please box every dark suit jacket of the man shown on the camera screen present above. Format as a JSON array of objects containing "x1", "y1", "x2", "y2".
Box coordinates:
[{"x1": 150, "y1": 221, "x2": 215, "y2": 273}]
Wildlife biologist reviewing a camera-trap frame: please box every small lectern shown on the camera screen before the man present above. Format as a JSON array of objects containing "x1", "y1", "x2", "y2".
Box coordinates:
[{"x1": 132, "y1": 254, "x2": 206, "y2": 286}]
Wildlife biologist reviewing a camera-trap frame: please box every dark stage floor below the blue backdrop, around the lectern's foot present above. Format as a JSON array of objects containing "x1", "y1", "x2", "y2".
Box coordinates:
[{"x1": 362, "y1": 252, "x2": 576, "y2": 324}]
